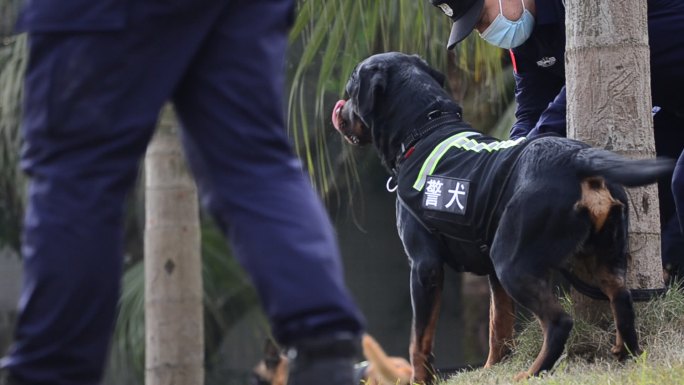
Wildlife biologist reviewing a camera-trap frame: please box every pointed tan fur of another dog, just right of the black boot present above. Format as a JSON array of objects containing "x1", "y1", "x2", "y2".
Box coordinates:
[{"x1": 362, "y1": 334, "x2": 413, "y2": 385}]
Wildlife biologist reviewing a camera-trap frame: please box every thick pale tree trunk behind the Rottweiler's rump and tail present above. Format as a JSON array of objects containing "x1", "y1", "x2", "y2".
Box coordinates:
[{"x1": 565, "y1": 0, "x2": 663, "y2": 311}]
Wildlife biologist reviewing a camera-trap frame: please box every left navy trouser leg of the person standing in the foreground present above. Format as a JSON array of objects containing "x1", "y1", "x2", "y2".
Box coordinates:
[{"x1": 2, "y1": 1, "x2": 220, "y2": 385}]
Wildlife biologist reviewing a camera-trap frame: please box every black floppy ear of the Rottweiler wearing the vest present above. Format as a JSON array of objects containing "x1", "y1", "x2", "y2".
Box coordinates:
[{"x1": 351, "y1": 61, "x2": 387, "y2": 126}]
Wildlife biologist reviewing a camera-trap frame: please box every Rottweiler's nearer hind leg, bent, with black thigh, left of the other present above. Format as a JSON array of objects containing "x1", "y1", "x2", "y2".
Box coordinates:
[{"x1": 490, "y1": 189, "x2": 590, "y2": 379}]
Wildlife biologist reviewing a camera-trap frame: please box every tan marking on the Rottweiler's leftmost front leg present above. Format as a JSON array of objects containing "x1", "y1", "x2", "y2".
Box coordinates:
[{"x1": 410, "y1": 285, "x2": 442, "y2": 384}]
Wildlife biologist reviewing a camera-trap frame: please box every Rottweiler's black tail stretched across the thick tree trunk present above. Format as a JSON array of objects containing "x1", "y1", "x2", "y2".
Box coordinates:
[{"x1": 574, "y1": 148, "x2": 675, "y2": 187}]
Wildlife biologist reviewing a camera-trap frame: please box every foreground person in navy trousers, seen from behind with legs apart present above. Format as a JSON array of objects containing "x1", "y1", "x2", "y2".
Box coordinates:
[{"x1": 1, "y1": 0, "x2": 363, "y2": 385}]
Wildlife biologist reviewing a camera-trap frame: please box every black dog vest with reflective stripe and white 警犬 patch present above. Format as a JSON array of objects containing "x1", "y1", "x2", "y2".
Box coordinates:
[{"x1": 397, "y1": 129, "x2": 528, "y2": 256}]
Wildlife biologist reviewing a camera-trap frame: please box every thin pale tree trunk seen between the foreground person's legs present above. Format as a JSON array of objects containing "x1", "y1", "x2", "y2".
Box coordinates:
[{"x1": 145, "y1": 107, "x2": 204, "y2": 385}]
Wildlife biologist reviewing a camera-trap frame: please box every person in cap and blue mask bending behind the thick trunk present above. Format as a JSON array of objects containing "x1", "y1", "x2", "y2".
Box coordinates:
[{"x1": 430, "y1": 0, "x2": 684, "y2": 283}]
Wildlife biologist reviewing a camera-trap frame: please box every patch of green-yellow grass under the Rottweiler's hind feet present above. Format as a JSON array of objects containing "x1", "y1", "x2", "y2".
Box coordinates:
[{"x1": 442, "y1": 290, "x2": 684, "y2": 385}]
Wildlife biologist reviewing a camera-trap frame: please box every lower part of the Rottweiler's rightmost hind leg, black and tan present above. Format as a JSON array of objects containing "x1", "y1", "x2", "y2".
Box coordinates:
[{"x1": 597, "y1": 266, "x2": 641, "y2": 360}]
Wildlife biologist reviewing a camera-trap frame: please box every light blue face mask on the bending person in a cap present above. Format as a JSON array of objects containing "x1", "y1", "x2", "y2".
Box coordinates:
[{"x1": 480, "y1": 0, "x2": 534, "y2": 49}]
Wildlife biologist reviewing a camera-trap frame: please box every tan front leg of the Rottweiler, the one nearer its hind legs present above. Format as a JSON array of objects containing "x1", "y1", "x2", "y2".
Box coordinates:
[{"x1": 485, "y1": 275, "x2": 515, "y2": 368}]
